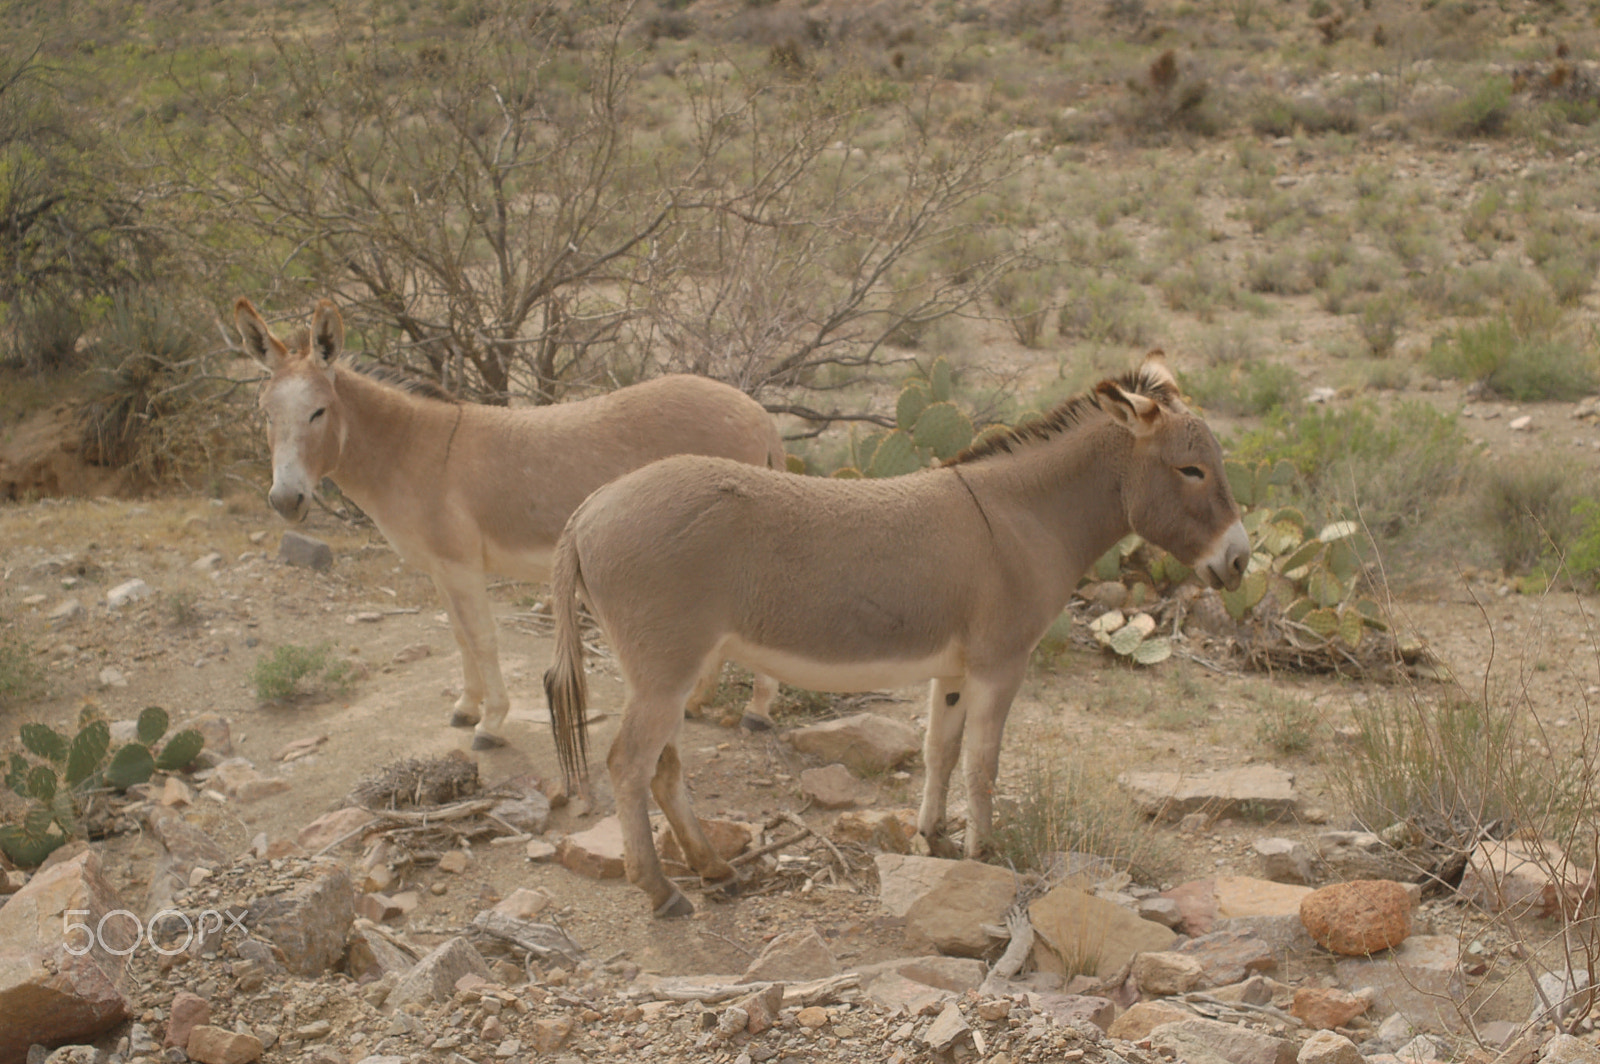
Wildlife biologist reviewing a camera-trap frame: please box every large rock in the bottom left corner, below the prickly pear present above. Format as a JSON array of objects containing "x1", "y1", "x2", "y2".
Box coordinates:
[{"x1": 0, "y1": 850, "x2": 136, "y2": 1064}]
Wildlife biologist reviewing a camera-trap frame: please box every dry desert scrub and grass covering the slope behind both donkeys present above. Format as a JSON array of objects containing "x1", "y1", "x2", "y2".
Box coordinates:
[{"x1": 0, "y1": 0, "x2": 1600, "y2": 1043}]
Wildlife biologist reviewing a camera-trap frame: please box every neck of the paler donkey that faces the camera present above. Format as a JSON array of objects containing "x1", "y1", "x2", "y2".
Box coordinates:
[{"x1": 328, "y1": 366, "x2": 461, "y2": 517}]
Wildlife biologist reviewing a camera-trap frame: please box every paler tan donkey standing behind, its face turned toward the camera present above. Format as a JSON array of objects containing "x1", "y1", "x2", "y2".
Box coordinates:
[{"x1": 234, "y1": 299, "x2": 787, "y2": 749}]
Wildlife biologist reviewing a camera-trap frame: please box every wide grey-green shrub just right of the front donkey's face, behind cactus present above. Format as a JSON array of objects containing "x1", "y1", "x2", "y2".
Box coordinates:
[{"x1": 1232, "y1": 403, "x2": 1475, "y2": 538}]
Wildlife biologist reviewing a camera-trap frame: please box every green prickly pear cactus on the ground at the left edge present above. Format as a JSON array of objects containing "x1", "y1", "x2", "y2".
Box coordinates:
[{"x1": 0, "y1": 706, "x2": 205, "y2": 866}]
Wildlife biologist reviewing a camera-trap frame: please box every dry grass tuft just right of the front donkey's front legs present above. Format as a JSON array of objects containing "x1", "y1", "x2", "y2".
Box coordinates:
[{"x1": 994, "y1": 741, "x2": 1173, "y2": 883}]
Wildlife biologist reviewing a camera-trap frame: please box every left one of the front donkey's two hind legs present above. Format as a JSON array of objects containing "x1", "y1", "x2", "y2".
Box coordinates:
[{"x1": 605, "y1": 685, "x2": 694, "y2": 917}]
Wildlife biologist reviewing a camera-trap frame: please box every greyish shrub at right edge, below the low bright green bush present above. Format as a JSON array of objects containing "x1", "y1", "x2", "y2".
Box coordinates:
[{"x1": 1482, "y1": 458, "x2": 1589, "y2": 573}]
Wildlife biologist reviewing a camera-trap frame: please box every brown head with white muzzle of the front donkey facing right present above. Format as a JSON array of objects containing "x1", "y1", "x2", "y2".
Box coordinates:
[{"x1": 1094, "y1": 350, "x2": 1250, "y2": 589}]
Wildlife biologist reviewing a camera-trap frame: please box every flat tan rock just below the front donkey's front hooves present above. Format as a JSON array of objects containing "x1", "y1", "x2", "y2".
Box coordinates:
[{"x1": 875, "y1": 853, "x2": 1011, "y2": 957}]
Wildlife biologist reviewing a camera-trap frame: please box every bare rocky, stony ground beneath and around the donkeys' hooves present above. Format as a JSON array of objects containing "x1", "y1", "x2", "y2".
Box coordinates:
[{"x1": 0, "y1": 486, "x2": 1595, "y2": 1064}]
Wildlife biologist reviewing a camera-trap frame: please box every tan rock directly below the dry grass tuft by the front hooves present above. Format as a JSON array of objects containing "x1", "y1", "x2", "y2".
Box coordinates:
[{"x1": 1024, "y1": 886, "x2": 1176, "y2": 979}]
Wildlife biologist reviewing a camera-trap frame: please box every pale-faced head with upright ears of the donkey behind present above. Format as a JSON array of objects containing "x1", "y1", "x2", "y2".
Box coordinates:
[{"x1": 234, "y1": 298, "x2": 344, "y2": 522}]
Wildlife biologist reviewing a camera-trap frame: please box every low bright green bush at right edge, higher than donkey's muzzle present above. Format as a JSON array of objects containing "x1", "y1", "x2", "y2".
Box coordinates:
[{"x1": 1426, "y1": 317, "x2": 1597, "y2": 402}]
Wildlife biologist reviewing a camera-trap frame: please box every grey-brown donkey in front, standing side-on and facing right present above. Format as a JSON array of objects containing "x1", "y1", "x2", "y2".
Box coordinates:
[{"x1": 544, "y1": 352, "x2": 1250, "y2": 917}]
